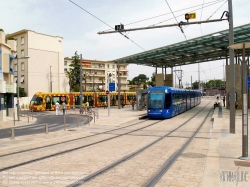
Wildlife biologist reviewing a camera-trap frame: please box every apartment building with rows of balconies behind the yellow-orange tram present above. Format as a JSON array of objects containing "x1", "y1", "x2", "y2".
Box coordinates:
[{"x1": 64, "y1": 57, "x2": 129, "y2": 91}]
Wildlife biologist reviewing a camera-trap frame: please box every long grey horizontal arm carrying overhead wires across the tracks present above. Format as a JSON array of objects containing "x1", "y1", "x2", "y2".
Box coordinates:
[{"x1": 97, "y1": 19, "x2": 228, "y2": 34}]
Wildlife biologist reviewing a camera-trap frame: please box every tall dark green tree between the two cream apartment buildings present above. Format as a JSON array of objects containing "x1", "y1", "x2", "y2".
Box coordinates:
[{"x1": 66, "y1": 52, "x2": 80, "y2": 91}]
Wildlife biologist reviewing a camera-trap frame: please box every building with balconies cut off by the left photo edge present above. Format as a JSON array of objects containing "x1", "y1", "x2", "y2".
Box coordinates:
[{"x1": 0, "y1": 29, "x2": 16, "y2": 121}]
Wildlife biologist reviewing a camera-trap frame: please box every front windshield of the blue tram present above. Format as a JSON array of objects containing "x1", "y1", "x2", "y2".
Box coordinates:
[{"x1": 148, "y1": 90, "x2": 165, "y2": 109}]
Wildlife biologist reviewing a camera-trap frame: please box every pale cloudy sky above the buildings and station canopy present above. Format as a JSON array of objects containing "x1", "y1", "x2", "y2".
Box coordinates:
[{"x1": 0, "y1": 0, "x2": 250, "y2": 87}]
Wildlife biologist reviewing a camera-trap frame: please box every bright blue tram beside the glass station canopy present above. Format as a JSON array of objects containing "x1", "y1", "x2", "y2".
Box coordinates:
[{"x1": 147, "y1": 86, "x2": 201, "y2": 118}]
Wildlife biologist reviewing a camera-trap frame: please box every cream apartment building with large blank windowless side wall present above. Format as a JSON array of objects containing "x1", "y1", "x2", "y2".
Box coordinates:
[{"x1": 6, "y1": 30, "x2": 69, "y2": 97}]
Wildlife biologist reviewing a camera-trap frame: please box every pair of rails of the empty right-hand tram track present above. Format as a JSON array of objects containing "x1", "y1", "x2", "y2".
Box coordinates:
[{"x1": 68, "y1": 101, "x2": 212, "y2": 187}]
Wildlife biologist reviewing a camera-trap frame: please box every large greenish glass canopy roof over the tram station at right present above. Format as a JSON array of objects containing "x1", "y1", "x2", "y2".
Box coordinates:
[{"x1": 113, "y1": 23, "x2": 250, "y2": 67}]
